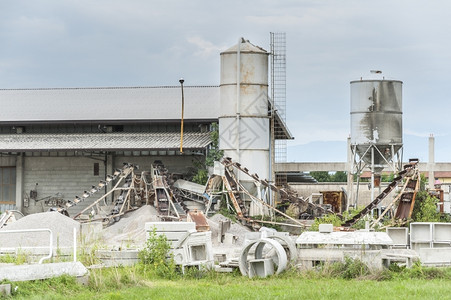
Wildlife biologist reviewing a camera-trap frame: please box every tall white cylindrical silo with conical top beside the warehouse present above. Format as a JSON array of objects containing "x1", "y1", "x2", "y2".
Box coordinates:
[{"x1": 219, "y1": 38, "x2": 270, "y2": 183}]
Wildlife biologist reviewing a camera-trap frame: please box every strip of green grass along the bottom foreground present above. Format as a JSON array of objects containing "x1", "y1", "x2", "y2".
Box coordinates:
[{"x1": 2, "y1": 266, "x2": 451, "y2": 300}]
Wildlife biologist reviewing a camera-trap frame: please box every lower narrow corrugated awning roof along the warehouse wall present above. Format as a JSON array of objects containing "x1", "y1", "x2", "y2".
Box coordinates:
[{"x1": 0, "y1": 132, "x2": 211, "y2": 152}]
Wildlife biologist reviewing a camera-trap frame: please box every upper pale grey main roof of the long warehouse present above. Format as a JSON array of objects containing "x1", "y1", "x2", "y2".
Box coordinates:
[{"x1": 0, "y1": 86, "x2": 219, "y2": 123}]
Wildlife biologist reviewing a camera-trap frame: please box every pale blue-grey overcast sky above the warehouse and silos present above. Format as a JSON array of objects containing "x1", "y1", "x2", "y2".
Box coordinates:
[{"x1": 0, "y1": 0, "x2": 451, "y2": 161}]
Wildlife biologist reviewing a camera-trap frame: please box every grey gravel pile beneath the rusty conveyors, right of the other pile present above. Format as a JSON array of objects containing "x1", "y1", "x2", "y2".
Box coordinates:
[{"x1": 102, "y1": 205, "x2": 160, "y2": 247}]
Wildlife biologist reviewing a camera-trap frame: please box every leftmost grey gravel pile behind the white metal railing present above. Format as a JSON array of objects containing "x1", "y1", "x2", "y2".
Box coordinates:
[{"x1": 0, "y1": 211, "x2": 80, "y2": 248}]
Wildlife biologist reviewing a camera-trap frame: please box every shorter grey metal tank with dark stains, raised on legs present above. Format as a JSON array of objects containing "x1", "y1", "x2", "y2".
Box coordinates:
[{"x1": 351, "y1": 80, "x2": 402, "y2": 173}]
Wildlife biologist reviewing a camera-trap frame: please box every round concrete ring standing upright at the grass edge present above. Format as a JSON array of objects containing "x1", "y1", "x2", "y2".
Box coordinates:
[{"x1": 238, "y1": 238, "x2": 288, "y2": 276}]
